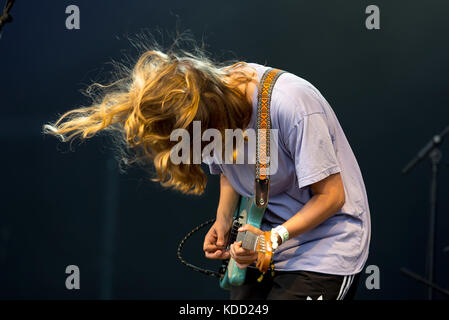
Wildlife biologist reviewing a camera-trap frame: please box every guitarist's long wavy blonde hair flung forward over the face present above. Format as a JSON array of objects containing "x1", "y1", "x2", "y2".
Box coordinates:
[{"x1": 43, "y1": 31, "x2": 252, "y2": 194}]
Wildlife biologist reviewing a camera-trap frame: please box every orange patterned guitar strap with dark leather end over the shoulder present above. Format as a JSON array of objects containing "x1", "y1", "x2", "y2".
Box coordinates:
[{"x1": 255, "y1": 68, "x2": 286, "y2": 208}]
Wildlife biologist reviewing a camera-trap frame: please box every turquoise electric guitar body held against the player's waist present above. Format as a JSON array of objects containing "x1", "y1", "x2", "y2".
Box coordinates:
[{"x1": 220, "y1": 196, "x2": 265, "y2": 290}]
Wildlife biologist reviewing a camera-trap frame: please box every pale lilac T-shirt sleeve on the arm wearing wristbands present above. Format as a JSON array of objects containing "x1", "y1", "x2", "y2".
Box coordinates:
[{"x1": 285, "y1": 112, "x2": 341, "y2": 188}]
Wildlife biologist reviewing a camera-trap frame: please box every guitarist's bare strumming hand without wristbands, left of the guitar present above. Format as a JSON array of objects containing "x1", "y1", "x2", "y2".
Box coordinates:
[{"x1": 203, "y1": 220, "x2": 232, "y2": 259}]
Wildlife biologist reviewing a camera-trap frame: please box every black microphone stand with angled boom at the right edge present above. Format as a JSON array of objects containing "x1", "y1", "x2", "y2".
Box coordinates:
[{"x1": 401, "y1": 126, "x2": 449, "y2": 300}]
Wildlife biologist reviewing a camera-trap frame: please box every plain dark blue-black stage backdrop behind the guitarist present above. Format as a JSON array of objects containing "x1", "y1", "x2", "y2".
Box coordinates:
[{"x1": 0, "y1": 0, "x2": 449, "y2": 299}]
